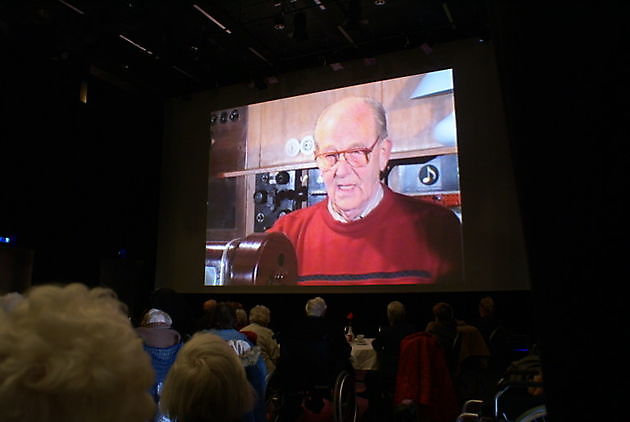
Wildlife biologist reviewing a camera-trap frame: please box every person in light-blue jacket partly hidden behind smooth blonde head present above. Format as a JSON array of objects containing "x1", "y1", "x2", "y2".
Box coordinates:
[{"x1": 207, "y1": 302, "x2": 267, "y2": 422}]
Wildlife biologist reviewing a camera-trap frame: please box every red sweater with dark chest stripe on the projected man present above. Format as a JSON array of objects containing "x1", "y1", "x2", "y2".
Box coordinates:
[{"x1": 269, "y1": 187, "x2": 461, "y2": 286}]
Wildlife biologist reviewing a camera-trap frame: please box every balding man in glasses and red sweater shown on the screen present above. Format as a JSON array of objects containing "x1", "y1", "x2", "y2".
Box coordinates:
[{"x1": 269, "y1": 97, "x2": 461, "y2": 285}]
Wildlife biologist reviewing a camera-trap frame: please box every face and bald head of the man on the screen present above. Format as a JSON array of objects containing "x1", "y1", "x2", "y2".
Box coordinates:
[{"x1": 315, "y1": 98, "x2": 391, "y2": 220}]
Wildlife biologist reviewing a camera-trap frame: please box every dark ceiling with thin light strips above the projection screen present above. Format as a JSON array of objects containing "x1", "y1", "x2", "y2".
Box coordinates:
[{"x1": 0, "y1": 0, "x2": 489, "y2": 97}]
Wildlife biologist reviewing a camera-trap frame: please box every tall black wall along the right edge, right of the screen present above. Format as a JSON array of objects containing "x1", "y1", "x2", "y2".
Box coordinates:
[{"x1": 494, "y1": 2, "x2": 630, "y2": 421}]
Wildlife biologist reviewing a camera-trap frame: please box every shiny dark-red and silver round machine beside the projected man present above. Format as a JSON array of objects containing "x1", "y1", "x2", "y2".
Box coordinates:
[{"x1": 204, "y1": 232, "x2": 297, "y2": 286}]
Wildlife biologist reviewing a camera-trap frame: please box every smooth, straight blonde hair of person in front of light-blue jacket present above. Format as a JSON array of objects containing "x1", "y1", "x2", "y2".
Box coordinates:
[{"x1": 160, "y1": 333, "x2": 254, "y2": 422}]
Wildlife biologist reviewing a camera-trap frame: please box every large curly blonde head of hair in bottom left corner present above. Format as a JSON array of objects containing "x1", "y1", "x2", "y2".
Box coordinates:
[{"x1": 0, "y1": 283, "x2": 155, "y2": 422}]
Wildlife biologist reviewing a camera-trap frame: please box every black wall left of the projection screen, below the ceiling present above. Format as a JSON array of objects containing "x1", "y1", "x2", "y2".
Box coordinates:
[{"x1": 0, "y1": 40, "x2": 163, "y2": 304}]
